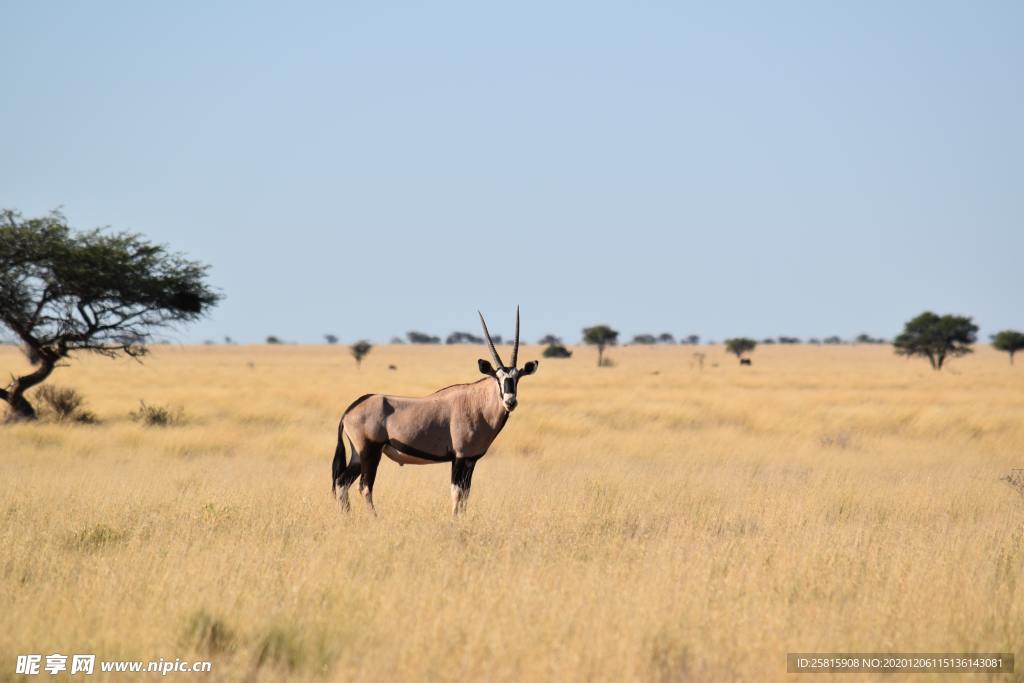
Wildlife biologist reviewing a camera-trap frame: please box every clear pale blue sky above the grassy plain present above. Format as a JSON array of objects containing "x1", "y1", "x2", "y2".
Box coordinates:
[{"x1": 0, "y1": 1, "x2": 1024, "y2": 342}]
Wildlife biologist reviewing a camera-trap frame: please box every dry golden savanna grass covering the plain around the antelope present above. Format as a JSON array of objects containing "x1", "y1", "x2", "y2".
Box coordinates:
[{"x1": 0, "y1": 346, "x2": 1024, "y2": 681}]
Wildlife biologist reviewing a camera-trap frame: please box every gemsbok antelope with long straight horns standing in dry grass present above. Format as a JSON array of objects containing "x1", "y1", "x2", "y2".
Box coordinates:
[{"x1": 331, "y1": 306, "x2": 541, "y2": 515}]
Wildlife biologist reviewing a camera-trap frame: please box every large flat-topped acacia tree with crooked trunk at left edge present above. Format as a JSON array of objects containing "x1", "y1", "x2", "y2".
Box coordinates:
[{"x1": 0, "y1": 209, "x2": 221, "y2": 420}]
